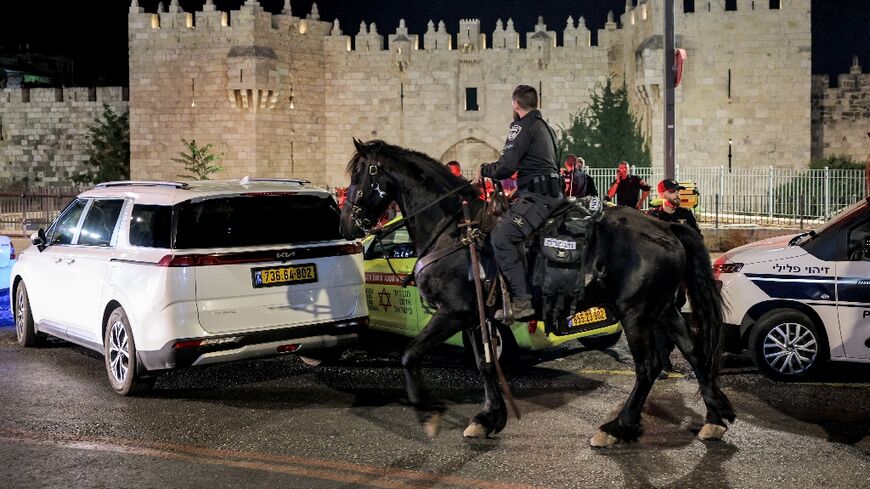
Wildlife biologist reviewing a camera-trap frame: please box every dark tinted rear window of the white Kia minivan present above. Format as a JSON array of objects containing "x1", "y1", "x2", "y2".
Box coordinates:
[{"x1": 174, "y1": 193, "x2": 342, "y2": 249}]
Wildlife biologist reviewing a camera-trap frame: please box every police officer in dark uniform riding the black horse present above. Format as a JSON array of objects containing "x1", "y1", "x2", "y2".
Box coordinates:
[{"x1": 480, "y1": 85, "x2": 563, "y2": 321}]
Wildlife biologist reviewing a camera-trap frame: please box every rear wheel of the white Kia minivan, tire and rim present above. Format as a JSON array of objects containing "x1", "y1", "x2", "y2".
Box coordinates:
[{"x1": 103, "y1": 307, "x2": 156, "y2": 396}]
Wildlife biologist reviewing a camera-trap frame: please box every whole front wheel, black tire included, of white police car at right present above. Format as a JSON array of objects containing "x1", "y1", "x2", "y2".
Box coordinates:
[{"x1": 749, "y1": 309, "x2": 828, "y2": 381}]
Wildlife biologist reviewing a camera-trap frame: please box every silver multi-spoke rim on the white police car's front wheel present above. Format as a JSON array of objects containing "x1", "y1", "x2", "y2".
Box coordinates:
[{"x1": 762, "y1": 323, "x2": 819, "y2": 375}]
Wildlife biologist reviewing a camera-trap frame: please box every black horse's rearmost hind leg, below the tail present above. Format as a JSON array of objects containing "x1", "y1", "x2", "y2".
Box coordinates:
[{"x1": 662, "y1": 309, "x2": 735, "y2": 440}]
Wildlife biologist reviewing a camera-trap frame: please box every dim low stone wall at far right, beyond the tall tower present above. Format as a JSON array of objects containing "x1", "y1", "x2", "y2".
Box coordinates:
[{"x1": 812, "y1": 58, "x2": 870, "y2": 161}]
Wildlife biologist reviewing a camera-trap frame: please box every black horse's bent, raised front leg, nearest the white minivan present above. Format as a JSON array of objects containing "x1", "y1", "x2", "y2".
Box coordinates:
[{"x1": 402, "y1": 311, "x2": 464, "y2": 438}]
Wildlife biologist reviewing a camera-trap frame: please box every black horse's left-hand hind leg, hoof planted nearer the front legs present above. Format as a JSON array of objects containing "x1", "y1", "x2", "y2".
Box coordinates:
[{"x1": 589, "y1": 315, "x2": 662, "y2": 447}]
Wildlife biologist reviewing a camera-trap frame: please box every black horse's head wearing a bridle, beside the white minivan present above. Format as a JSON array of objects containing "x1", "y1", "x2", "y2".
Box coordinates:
[{"x1": 340, "y1": 139, "x2": 398, "y2": 239}]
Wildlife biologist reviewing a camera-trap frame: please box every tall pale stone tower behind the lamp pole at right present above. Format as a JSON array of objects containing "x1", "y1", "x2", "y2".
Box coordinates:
[{"x1": 611, "y1": 0, "x2": 811, "y2": 172}]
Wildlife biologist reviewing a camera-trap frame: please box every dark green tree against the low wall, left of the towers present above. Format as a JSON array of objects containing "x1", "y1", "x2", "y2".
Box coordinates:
[{"x1": 70, "y1": 105, "x2": 130, "y2": 184}]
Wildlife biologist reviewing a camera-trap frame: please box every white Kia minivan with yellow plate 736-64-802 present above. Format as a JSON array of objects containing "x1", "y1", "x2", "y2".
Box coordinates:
[{"x1": 10, "y1": 178, "x2": 368, "y2": 395}]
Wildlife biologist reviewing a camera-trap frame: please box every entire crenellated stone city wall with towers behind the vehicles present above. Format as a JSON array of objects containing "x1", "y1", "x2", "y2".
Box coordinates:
[{"x1": 0, "y1": 0, "x2": 870, "y2": 186}]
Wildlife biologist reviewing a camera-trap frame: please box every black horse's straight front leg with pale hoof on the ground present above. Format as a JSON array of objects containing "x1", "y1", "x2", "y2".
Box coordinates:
[{"x1": 462, "y1": 327, "x2": 508, "y2": 438}]
